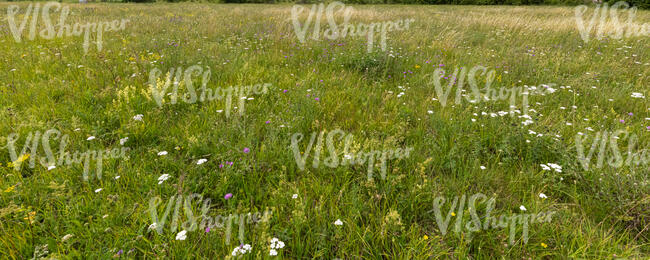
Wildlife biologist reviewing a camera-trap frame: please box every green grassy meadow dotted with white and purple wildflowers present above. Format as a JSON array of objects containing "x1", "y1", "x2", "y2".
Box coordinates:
[{"x1": 0, "y1": 2, "x2": 650, "y2": 259}]
